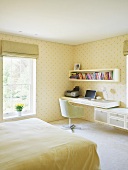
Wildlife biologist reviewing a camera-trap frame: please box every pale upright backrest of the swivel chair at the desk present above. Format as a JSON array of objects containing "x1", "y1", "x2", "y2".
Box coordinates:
[{"x1": 59, "y1": 99, "x2": 69, "y2": 117}]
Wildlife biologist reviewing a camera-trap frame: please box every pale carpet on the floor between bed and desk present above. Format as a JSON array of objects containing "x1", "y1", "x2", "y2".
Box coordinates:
[{"x1": 51, "y1": 119, "x2": 128, "y2": 170}]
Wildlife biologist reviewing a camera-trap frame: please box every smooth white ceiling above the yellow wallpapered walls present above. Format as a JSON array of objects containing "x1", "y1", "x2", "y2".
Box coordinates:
[{"x1": 0, "y1": 0, "x2": 128, "y2": 45}]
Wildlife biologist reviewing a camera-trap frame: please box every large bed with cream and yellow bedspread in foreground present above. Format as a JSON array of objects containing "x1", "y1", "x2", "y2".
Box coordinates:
[{"x1": 0, "y1": 118, "x2": 100, "y2": 170}]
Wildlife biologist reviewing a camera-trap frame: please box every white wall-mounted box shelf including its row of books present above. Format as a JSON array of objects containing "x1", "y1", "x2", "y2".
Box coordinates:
[{"x1": 69, "y1": 68, "x2": 120, "y2": 82}]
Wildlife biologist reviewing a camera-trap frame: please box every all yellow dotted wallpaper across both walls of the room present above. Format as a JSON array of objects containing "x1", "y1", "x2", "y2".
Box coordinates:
[{"x1": 0, "y1": 34, "x2": 128, "y2": 122}]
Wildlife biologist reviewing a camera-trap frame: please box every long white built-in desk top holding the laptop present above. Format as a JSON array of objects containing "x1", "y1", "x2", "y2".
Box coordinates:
[{"x1": 62, "y1": 97, "x2": 120, "y2": 109}]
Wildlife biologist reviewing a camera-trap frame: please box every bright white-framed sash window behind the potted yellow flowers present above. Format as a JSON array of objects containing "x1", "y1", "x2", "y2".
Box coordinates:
[{"x1": 3, "y1": 57, "x2": 36, "y2": 119}]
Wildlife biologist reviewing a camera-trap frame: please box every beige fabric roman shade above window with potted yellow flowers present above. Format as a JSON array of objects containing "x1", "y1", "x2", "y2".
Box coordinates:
[{"x1": 0, "y1": 40, "x2": 39, "y2": 58}]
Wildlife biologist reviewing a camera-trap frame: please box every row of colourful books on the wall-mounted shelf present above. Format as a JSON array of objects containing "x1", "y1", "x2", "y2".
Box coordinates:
[{"x1": 70, "y1": 71, "x2": 113, "y2": 80}]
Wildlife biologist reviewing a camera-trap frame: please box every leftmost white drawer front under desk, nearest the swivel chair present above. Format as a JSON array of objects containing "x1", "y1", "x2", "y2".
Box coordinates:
[{"x1": 94, "y1": 110, "x2": 107, "y2": 123}]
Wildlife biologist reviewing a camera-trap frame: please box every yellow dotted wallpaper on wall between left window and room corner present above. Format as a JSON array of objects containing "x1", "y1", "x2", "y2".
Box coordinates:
[{"x1": 0, "y1": 34, "x2": 74, "y2": 122}]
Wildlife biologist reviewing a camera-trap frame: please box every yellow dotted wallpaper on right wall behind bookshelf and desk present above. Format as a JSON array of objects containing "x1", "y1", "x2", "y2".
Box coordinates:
[{"x1": 73, "y1": 35, "x2": 128, "y2": 121}]
